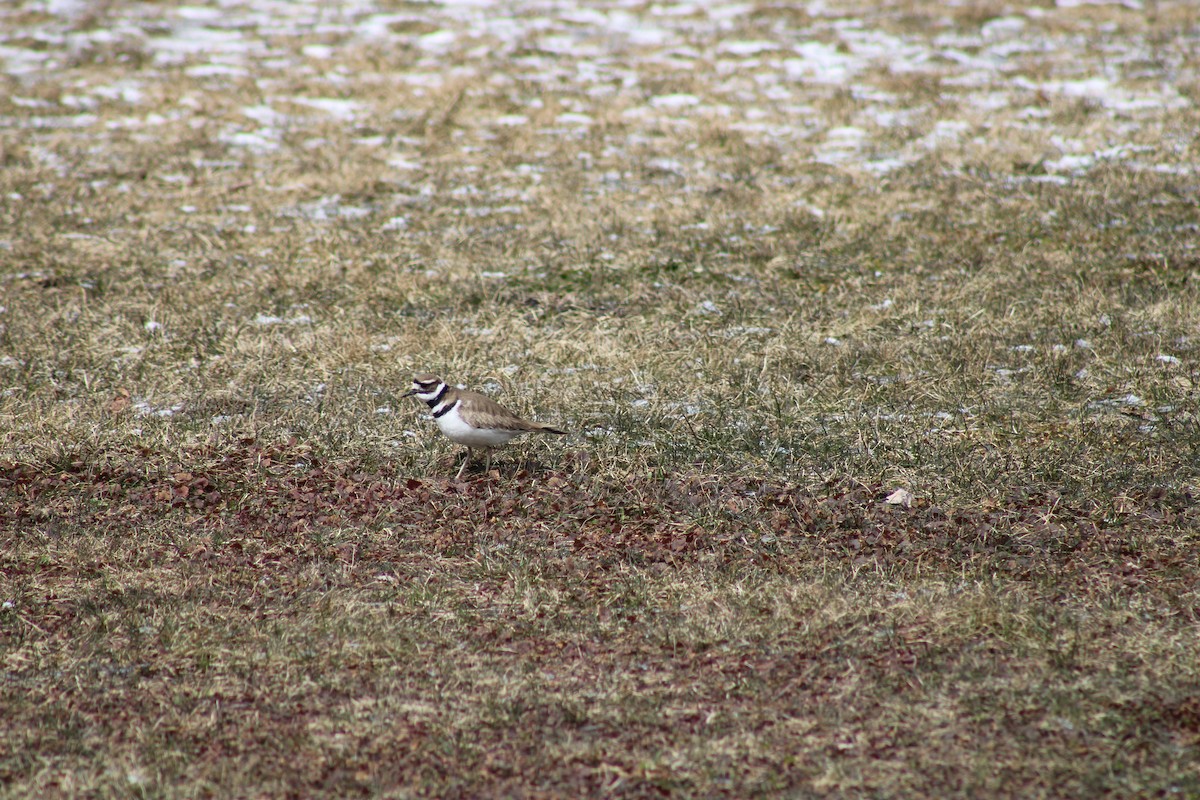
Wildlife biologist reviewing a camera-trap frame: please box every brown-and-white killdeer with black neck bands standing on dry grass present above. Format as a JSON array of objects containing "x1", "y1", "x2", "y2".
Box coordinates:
[{"x1": 404, "y1": 372, "x2": 566, "y2": 479}]
